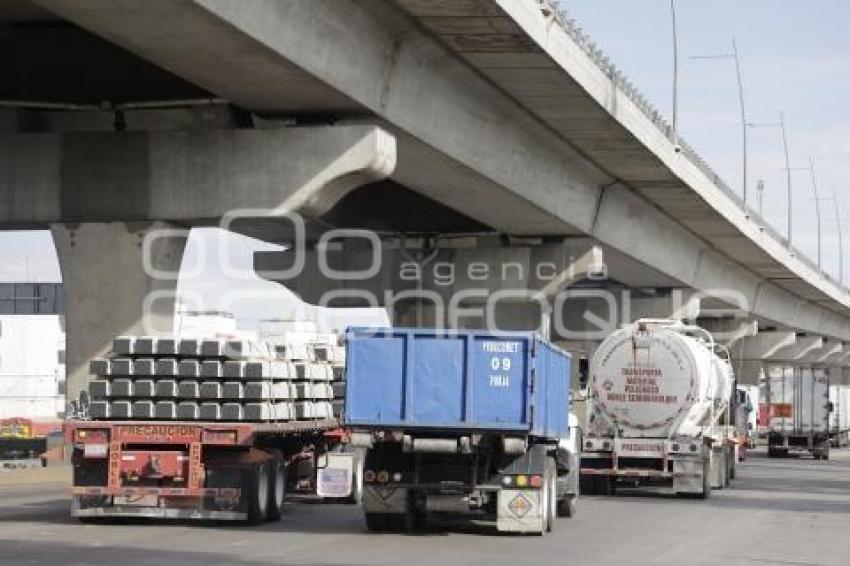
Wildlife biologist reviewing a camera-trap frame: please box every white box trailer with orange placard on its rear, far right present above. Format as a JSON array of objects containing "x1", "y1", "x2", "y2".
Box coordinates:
[{"x1": 766, "y1": 366, "x2": 831, "y2": 460}]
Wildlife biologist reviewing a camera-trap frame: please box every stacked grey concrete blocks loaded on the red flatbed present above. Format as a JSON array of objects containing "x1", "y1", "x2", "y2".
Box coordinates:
[{"x1": 89, "y1": 332, "x2": 345, "y2": 422}]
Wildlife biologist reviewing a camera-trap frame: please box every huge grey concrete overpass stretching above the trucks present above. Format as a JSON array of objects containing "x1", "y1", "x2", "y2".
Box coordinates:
[{"x1": 0, "y1": 0, "x2": 850, "y2": 400}]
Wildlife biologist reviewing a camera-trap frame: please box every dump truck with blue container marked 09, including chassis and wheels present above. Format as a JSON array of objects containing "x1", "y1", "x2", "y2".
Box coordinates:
[{"x1": 345, "y1": 328, "x2": 578, "y2": 534}]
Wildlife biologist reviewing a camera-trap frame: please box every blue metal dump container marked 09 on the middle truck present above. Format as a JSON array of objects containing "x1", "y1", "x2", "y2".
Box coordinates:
[{"x1": 345, "y1": 328, "x2": 570, "y2": 440}]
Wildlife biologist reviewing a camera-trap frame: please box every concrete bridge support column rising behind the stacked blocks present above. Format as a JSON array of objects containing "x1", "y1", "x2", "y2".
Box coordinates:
[{"x1": 51, "y1": 222, "x2": 186, "y2": 401}]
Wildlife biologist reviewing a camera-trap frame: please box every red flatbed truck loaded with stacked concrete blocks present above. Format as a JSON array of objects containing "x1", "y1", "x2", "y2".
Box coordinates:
[{"x1": 65, "y1": 336, "x2": 360, "y2": 523}]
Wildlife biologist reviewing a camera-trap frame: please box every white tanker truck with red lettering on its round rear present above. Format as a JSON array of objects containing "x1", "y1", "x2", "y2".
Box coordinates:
[{"x1": 581, "y1": 319, "x2": 737, "y2": 498}]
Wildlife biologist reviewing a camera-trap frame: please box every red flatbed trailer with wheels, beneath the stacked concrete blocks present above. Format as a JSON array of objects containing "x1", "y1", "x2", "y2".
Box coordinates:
[{"x1": 65, "y1": 419, "x2": 359, "y2": 524}]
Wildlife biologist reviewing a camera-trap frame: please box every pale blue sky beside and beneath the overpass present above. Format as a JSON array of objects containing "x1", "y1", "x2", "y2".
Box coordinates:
[{"x1": 0, "y1": 0, "x2": 850, "y2": 323}]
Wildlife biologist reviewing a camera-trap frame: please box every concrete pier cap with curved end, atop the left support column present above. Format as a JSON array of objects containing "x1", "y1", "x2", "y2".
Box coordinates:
[{"x1": 0, "y1": 126, "x2": 396, "y2": 228}]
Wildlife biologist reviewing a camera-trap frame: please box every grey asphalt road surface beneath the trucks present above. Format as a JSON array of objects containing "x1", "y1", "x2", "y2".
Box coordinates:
[{"x1": 0, "y1": 451, "x2": 850, "y2": 566}]
